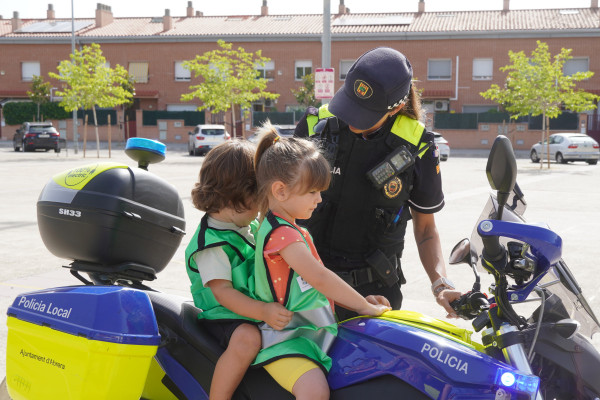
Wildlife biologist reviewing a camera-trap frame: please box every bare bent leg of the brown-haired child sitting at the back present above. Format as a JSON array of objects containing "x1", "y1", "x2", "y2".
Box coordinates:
[{"x1": 209, "y1": 324, "x2": 262, "y2": 400}]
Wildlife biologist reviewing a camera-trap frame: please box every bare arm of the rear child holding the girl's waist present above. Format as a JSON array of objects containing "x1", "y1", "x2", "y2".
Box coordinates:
[{"x1": 206, "y1": 279, "x2": 293, "y2": 330}]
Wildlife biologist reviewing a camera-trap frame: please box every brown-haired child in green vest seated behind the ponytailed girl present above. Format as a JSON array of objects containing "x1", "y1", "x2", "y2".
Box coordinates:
[{"x1": 185, "y1": 140, "x2": 292, "y2": 400}]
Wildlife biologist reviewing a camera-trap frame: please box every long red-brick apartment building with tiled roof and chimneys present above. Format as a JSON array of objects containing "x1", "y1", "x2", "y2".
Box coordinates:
[{"x1": 0, "y1": 0, "x2": 600, "y2": 147}]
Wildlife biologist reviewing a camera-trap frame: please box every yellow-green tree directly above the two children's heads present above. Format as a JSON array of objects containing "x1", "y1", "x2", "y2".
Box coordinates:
[{"x1": 181, "y1": 40, "x2": 279, "y2": 137}]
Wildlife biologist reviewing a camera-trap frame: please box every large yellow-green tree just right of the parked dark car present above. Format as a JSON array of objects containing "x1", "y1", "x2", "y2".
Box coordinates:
[{"x1": 49, "y1": 43, "x2": 133, "y2": 157}]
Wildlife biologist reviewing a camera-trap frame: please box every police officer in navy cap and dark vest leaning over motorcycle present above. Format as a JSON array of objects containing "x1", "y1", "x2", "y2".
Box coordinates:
[{"x1": 295, "y1": 47, "x2": 460, "y2": 319}]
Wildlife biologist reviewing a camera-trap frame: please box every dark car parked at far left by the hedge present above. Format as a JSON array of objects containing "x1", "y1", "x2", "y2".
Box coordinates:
[{"x1": 13, "y1": 122, "x2": 66, "y2": 153}]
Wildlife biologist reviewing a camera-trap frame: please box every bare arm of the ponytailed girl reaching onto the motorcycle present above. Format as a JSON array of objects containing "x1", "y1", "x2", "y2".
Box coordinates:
[{"x1": 279, "y1": 242, "x2": 390, "y2": 315}]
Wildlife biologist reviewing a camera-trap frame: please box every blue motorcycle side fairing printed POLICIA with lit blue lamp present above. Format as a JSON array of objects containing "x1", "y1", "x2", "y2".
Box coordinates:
[{"x1": 328, "y1": 317, "x2": 539, "y2": 399}]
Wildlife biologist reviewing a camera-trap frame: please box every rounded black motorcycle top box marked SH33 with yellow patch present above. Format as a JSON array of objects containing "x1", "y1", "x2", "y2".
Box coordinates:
[{"x1": 37, "y1": 163, "x2": 185, "y2": 279}]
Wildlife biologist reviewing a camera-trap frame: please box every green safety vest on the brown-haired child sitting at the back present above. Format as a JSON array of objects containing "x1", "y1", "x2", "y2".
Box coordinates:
[{"x1": 185, "y1": 214, "x2": 256, "y2": 322}]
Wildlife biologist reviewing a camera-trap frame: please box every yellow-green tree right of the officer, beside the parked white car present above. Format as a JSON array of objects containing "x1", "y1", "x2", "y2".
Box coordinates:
[{"x1": 480, "y1": 40, "x2": 599, "y2": 168}]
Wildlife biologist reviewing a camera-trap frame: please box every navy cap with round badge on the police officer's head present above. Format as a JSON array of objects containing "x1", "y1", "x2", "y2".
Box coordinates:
[{"x1": 329, "y1": 47, "x2": 412, "y2": 129}]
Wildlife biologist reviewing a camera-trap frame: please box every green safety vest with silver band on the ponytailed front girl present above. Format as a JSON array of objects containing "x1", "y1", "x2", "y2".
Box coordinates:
[{"x1": 254, "y1": 211, "x2": 337, "y2": 371}]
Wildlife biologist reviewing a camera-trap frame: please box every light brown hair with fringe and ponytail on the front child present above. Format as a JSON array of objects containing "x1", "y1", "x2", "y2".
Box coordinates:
[{"x1": 254, "y1": 121, "x2": 331, "y2": 219}]
